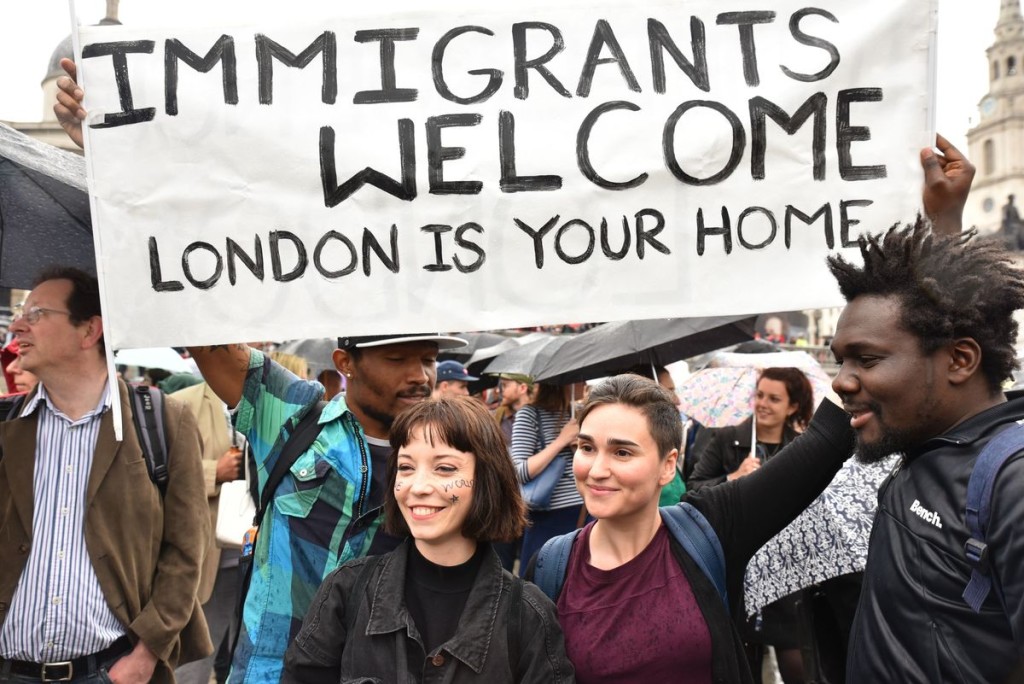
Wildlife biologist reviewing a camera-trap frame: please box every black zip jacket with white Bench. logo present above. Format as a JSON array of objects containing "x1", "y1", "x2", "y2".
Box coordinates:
[{"x1": 847, "y1": 394, "x2": 1024, "y2": 684}]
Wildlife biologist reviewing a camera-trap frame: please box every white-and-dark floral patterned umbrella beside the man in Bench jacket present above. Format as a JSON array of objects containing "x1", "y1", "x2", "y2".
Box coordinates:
[{"x1": 743, "y1": 456, "x2": 899, "y2": 615}]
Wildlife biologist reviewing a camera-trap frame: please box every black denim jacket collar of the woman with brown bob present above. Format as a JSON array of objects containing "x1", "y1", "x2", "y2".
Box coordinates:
[{"x1": 367, "y1": 539, "x2": 504, "y2": 674}]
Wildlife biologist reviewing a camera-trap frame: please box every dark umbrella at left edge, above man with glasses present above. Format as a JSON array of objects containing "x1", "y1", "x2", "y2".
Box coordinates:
[{"x1": 0, "y1": 124, "x2": 96, "y2": 289}]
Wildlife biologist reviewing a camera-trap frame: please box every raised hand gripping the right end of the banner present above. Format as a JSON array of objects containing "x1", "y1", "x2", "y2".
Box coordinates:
[{"x1": 921, "y1": 135, "x2": 975, "y2": 236}]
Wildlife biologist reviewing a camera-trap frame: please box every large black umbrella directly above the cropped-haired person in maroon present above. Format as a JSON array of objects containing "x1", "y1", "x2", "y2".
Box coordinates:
[{"x1": 534, "y1": 316, "x2": 755, "y2": 385}]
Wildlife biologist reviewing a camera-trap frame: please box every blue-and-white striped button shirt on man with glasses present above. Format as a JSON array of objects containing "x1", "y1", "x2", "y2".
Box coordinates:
[{"x1": 0, "y1": 382, "x2": 125, "y2": 662}]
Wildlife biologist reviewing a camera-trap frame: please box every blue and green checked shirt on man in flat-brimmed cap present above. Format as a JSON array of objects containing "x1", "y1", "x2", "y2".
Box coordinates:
[{"x1": 229, "y1": 350, "x2": 382, "y2": 684}]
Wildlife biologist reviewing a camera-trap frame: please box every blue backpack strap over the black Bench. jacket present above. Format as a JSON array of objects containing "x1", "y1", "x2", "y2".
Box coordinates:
[{"x1": 964, "y1": 423, "x2": 1024, "y2": 612}]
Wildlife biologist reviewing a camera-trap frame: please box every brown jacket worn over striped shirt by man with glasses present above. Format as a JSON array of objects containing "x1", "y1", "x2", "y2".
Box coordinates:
[{"x1": 0, "y1": 381, "x2": 213, "y2": 684}]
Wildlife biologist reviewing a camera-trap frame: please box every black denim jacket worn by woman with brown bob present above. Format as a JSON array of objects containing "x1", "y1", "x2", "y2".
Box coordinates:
[{"x1": 282, "y1": 541, "x2": 574, "y2": 684}]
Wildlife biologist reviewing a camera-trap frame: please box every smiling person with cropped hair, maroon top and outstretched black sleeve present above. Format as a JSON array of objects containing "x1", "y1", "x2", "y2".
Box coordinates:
[{"x1": 546, "y1": 375, "x2": 853, "y2": 683}]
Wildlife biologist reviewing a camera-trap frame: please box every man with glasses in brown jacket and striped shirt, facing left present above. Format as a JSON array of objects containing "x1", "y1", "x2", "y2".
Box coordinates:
[{"x1": 0, "y1": 268, "x2": 212, "y2": 684}]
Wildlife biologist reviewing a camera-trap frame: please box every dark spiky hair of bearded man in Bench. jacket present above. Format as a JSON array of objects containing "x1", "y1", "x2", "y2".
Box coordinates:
[{"x1": 828, "y1": 216, "x2": 1024, "y2": 392}]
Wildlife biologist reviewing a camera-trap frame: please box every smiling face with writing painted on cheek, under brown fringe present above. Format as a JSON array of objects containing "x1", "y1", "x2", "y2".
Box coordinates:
[{"x1": 394, "y1": 426, "x2": 476, "y2": 564}]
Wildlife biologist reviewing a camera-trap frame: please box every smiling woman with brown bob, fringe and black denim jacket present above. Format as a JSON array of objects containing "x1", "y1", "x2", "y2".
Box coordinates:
[{"x1": 282, "y1": 396, "x2": 574, "y2": 684}]
